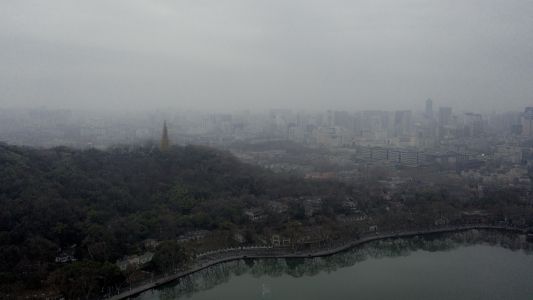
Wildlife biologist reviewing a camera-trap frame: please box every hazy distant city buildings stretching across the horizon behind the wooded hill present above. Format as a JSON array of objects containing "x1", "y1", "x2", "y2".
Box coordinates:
[{"x1": 0, "y1": 99, "x2": 533, "y2": 179}]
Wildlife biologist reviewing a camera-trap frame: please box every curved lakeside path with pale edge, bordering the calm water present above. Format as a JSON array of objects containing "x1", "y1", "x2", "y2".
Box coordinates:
[{"x1": 107, "y1": 225, "x2": 527, "y2": 300}]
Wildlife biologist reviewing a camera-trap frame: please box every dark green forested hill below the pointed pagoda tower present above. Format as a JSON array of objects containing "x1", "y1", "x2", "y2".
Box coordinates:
[{"x1": 0, "y1": 144, "x2": 334, "y2": 292}]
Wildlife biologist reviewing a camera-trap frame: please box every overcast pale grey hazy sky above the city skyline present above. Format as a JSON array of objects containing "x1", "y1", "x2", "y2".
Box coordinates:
[{"x1": 0, "y1": 0, "x2": 533, "y2": 111}]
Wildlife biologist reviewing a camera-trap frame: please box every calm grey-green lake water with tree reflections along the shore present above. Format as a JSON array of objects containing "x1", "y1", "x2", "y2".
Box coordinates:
[{"x1": 137, "y1": 231, "x2": 533, "y2": 300}]
